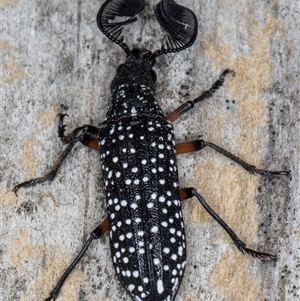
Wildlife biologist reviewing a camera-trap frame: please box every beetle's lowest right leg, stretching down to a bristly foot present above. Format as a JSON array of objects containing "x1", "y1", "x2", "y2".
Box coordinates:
[{"x1": 179, "y1": 187, "x2": 277, "y2": 261}]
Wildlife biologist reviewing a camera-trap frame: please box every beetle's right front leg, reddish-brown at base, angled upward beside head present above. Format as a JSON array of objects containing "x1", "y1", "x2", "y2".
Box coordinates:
[{"x1": 166, "y1": 69, "x2": 235, "y2": 122}]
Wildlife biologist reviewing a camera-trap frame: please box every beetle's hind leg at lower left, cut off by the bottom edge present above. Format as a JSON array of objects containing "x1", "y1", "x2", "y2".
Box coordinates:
[{"x1": 45, "y1": 217, "x2": 108, "y2": 301}]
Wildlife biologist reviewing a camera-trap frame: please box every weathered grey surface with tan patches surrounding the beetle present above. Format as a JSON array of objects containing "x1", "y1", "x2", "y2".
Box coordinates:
[{"x1": 0, "y1": 0, "x2": 300, "y2": 301}]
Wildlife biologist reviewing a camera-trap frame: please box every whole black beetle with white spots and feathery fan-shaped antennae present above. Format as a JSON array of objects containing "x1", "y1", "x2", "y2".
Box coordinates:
[{"x1": 14, "y1": 0, "x2": 290, "y2": 301}]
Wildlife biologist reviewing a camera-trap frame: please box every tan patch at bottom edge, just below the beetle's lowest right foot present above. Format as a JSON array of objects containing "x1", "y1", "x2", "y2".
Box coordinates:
[{"x1": 209, "y1": 250, "x2": 260, "y2": 301}]
